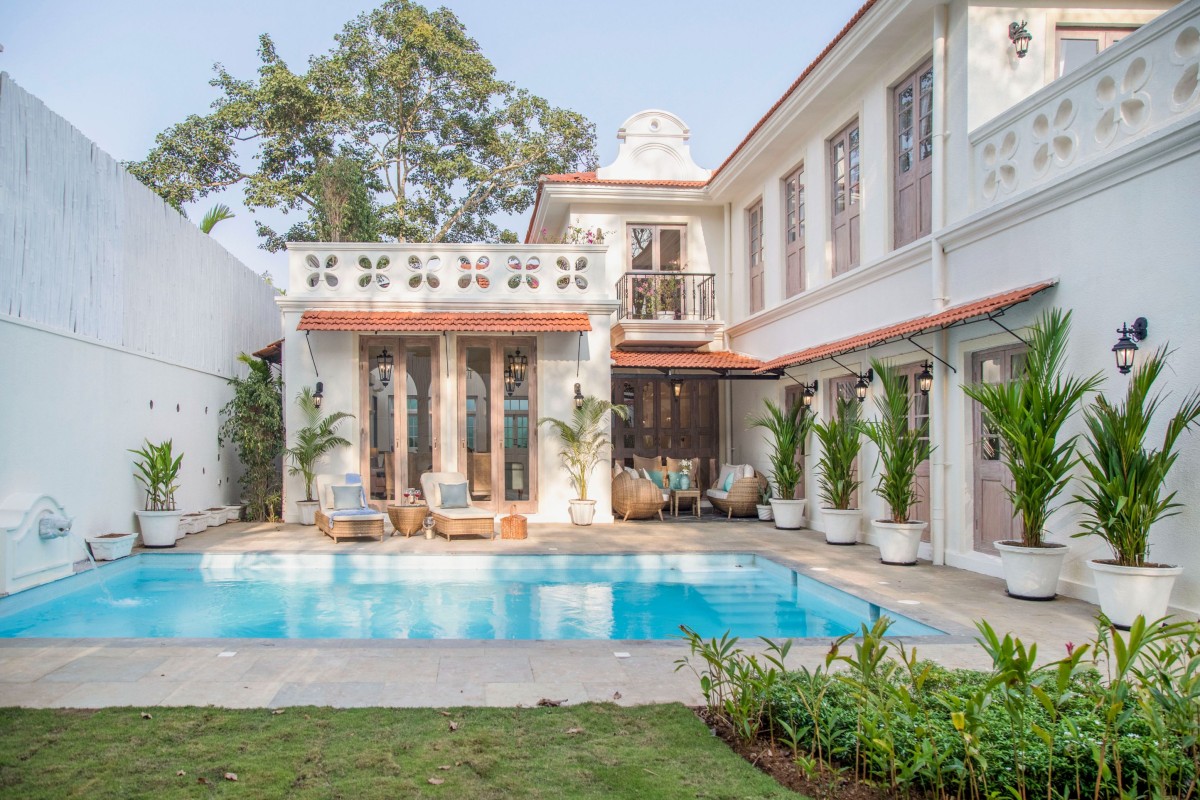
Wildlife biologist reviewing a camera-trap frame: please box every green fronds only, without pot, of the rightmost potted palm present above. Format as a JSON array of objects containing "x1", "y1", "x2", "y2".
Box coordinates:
[{"x1": 1075, "y1": 348, "x2": 1200, "y2": 566}]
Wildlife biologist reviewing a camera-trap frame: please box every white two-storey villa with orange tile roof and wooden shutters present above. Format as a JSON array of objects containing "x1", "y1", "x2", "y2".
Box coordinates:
[{"x1": 277, "y1": 0, "x2": 1200, "y2": 610}]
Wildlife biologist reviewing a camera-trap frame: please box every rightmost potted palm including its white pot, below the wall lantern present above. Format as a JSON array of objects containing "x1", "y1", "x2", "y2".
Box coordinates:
[{"x1": 1075, "y1": 349, "x2": 1200, "y2": 628}]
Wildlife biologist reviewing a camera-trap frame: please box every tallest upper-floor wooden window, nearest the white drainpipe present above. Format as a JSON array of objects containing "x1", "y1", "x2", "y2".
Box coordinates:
[{"x1": 892, "y1": 61, "x2": 934, "y2": 247}]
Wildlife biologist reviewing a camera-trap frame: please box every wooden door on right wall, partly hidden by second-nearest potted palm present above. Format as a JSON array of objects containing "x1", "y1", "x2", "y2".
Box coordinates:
[{"x1": 971, "y1": 345, "x2": 1025, "y2": 553}]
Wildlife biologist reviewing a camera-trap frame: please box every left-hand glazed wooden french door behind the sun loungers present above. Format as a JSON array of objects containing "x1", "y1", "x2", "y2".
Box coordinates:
[{"x1": 359, "y1": 336, "x2": 442, "y2": 509}]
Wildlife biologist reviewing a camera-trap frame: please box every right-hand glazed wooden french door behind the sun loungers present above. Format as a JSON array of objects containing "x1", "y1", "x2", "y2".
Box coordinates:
[{"x1": 456, "y1": 337, "x2": 538, "y2": 513}]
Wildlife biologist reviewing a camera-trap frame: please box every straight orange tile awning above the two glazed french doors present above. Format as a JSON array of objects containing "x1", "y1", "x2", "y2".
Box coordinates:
[{"x1": 296, "y1": 311, "x2": 592, "y2": 333}]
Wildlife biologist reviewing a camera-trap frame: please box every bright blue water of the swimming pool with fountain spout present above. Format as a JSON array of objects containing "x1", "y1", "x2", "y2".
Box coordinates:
[{"x1": 0, "y1": 553, "x2": 942, "y2": 639}]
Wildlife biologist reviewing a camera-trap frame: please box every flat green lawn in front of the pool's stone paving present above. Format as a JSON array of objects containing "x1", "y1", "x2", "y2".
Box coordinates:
[{"x1": 0, "y1": 704, "x2": 798, "y2": 800}]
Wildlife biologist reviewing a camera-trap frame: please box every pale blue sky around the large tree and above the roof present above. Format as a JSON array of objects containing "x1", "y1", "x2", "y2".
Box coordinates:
[{"x1": 0, "y1": 0, "x2": 862, "y2": 287}]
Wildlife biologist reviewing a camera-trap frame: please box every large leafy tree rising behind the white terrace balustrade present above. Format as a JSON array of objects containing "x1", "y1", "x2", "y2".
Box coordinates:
[{"x1": 128, "y1": 0, "x2": 595, "y2": 251}]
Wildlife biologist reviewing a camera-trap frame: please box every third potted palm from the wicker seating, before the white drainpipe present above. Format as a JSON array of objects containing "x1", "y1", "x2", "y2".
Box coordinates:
[{"x1": 862, "y1": 359, "x2": 929, "y2": 566}]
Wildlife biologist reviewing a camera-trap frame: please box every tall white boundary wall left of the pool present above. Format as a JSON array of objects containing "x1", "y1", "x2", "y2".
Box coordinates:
[{"x1": 0, "y1": 73, "x2": 281, "y2": 575}]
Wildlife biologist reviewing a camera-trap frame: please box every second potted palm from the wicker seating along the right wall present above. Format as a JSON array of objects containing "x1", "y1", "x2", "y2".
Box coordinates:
[{"x1": 812, "y1": 398, "x2": 863, "y2": 545}]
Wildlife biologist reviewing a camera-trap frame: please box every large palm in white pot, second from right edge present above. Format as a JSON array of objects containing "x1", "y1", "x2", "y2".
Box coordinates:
[{"x1": 962, "y1": 308, "x2": 1100, "y2": 600}]
